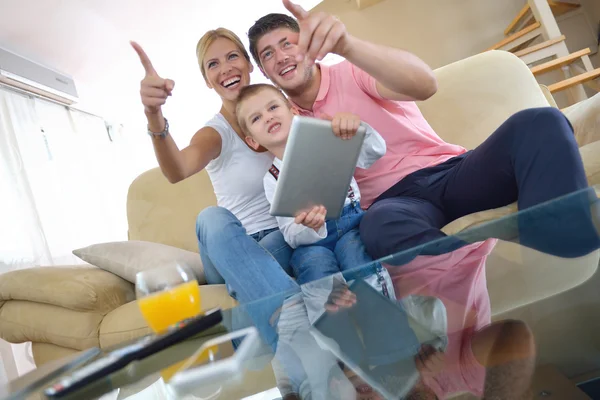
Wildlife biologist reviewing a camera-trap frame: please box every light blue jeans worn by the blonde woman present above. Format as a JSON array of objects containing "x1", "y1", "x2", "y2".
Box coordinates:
[{"x1": 196, "y1": 207, "x2": 300, "y2": 349}]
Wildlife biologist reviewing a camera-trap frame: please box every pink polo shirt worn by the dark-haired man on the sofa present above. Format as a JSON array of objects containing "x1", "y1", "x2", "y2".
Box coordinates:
[{"x1": 297, "y1": 61, "x2": 466, "y2": 208}]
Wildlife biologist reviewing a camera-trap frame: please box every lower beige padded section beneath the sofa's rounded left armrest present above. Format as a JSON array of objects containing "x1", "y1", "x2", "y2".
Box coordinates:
[{"x1": 0, "y1": 300, "x2": 104, "y2": 350}]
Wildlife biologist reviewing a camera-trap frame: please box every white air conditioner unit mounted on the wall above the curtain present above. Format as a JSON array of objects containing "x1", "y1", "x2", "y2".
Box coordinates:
[{"x1": 0, "y1": 48, "x2": 79, "y2": 104}]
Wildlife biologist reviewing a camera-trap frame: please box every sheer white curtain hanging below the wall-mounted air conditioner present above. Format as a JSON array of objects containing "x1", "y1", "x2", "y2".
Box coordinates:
[{"x1": 0, "y1": 88, "x2": 142, "y2": 272}]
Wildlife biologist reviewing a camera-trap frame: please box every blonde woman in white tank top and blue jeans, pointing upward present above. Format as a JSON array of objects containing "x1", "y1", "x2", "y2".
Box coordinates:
[{"x1": 132, "y1": 28, "x2": 400, "y2": 400}]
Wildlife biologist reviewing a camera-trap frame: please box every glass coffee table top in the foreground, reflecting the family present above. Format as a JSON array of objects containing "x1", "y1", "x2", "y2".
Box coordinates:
[{"x1": 5, "y1": 187, "x2": 600, "y2": 400}]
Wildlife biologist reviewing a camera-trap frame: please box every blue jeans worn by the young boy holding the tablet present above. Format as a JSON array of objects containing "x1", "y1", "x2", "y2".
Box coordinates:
[{"x1": 290, "y1": 203, "x2": 380, "y2": 285}]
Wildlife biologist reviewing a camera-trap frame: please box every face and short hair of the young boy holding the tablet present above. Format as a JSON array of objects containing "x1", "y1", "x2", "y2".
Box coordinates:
[{"x1": 238, "y1": 89, "x2": 294, "y2": 150}]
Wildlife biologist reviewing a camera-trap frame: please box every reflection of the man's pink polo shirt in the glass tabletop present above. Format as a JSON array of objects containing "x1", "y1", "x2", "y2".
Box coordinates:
[{"x1": 388, "y1": 239, "x2": 496, "y2": 400}]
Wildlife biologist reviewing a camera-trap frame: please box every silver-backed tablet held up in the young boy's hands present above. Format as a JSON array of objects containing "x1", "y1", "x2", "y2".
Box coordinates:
[{"x1": 270, "y1": 116, "x2": 366, "y2": 219}]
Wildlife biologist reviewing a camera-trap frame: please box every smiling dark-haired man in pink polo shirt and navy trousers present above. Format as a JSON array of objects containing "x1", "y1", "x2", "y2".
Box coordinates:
[{"x1": 248, "y1": 0, "x2": 600, "y2": 259}]
